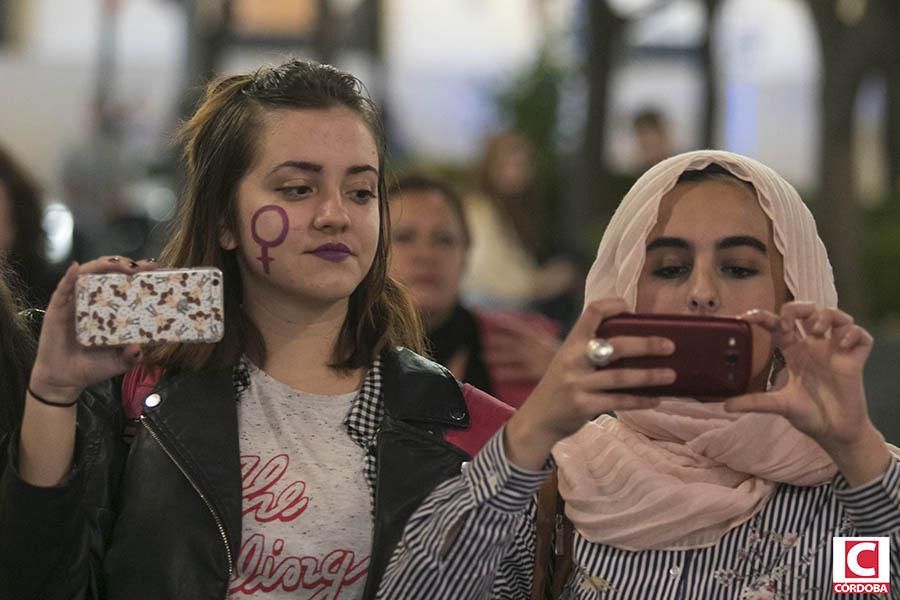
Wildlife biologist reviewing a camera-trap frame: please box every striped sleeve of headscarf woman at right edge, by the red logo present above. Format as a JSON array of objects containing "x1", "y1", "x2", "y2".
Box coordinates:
[{"x1": 834, "y1": 458, "x2": 900, "y2": 593}]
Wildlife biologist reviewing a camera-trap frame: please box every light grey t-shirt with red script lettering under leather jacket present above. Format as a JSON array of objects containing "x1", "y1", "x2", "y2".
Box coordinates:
[{"x1": 228, "y1": 364, "x2": 373, "y2": 600}]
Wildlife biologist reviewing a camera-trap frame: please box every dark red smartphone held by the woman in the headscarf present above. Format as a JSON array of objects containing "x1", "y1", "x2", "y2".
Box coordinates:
[{"x1": 597, "y1": 314, "x2": 753, "y2": 402}]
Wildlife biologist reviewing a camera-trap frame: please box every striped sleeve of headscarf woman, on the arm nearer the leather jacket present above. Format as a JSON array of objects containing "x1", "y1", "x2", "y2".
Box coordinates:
[{"x1": 377, "y1": 429, "x2": 552, "y2": 600}]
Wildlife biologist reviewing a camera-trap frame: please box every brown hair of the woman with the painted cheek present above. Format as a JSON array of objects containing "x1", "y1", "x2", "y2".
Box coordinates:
[{"x1": 145, "y1": 60, "x2": 424, "y2": 370}]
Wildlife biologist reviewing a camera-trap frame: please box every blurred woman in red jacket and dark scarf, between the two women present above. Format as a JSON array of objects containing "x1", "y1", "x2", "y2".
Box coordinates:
[{"x1": 389, "y1": 173, "x2": 559, "y2": 407}]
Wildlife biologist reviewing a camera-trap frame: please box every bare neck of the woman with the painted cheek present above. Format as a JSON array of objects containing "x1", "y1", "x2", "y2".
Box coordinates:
[{"x1": 244, "y1": 290, "x2": 363, "y2": 394}]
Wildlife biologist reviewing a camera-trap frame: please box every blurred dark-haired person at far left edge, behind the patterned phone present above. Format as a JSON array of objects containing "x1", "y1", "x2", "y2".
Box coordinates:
[{"x1": 0, "y1": 147, "x2": 62, "y2": 307}]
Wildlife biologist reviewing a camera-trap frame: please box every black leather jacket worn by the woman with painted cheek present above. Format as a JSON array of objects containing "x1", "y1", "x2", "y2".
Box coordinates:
[{"x1": 0, "y1": 349, "x2": 469, "y2": 600}]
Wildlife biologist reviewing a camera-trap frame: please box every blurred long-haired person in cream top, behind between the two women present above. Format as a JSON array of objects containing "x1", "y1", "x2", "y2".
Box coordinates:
[{"x1": 463, "y1": 132, "x2": 580, "y2": 318}]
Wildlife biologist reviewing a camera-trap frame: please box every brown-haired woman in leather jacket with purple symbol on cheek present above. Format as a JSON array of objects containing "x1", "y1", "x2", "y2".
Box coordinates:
[{"x1": 0, "y1": 60, "x2": 510, "y2": 599}]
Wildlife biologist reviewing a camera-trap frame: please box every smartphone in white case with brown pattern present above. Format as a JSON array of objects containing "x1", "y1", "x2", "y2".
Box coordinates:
[{"x1": 75, "y1": 267, "x2": 225, "y2": 347}]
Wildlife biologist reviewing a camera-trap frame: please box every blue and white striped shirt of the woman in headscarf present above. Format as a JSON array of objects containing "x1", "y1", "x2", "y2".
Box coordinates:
[{"x1": 378, "y1": 430, "x2": 900, "y2": 600}]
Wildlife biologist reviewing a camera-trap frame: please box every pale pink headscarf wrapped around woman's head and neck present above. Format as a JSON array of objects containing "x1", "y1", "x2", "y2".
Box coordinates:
[{"x1": 553, "y1": 150, "x2": 837, "y2": 550}]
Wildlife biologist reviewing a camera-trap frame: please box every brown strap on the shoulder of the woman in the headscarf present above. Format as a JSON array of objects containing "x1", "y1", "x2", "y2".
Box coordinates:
[{"x1": 531, "y1": 469, "x2": 574, "y2": 600}]
